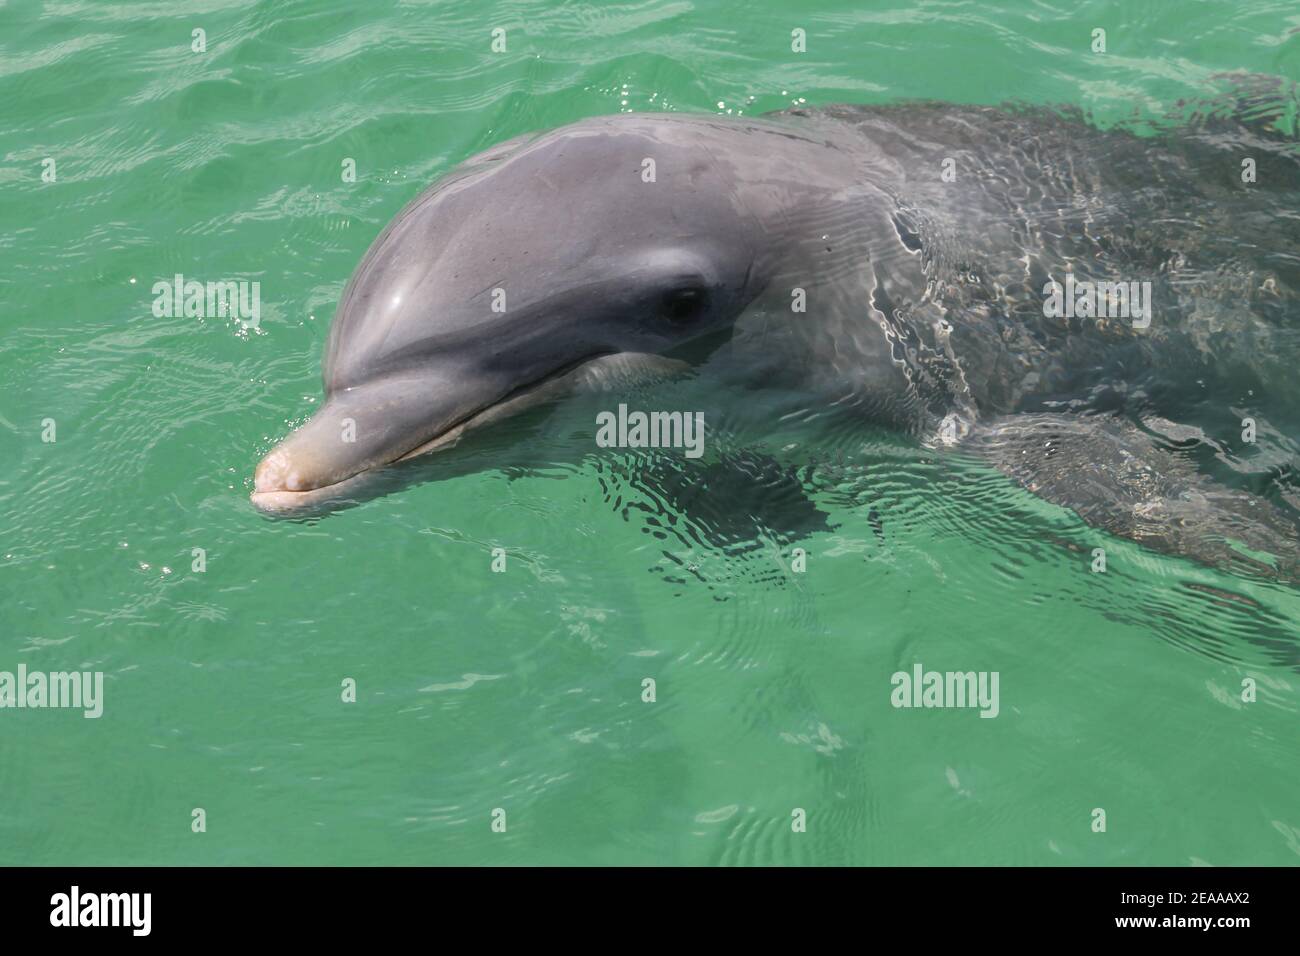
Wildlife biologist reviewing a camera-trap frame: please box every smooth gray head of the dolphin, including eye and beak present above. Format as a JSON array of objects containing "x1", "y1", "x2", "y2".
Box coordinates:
[{"x1": 252, "y1": 116, "x2": 766, "y2": 512}]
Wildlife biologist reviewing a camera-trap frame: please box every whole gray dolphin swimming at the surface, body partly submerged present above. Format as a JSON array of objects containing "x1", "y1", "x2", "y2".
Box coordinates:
[{"x1": 252, "y1": 86, "x2": 1300, "y2": 580}]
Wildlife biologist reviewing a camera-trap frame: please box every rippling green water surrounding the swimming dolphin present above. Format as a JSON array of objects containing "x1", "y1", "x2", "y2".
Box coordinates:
[{"x1": 0, "y1": 0, "x2": 1300, "y2": 865}]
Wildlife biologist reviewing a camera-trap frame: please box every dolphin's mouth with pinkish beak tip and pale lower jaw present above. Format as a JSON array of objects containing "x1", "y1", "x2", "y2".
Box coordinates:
[{"x1": 248, "y1": 352, "x2": 624, "y2": 515}]
